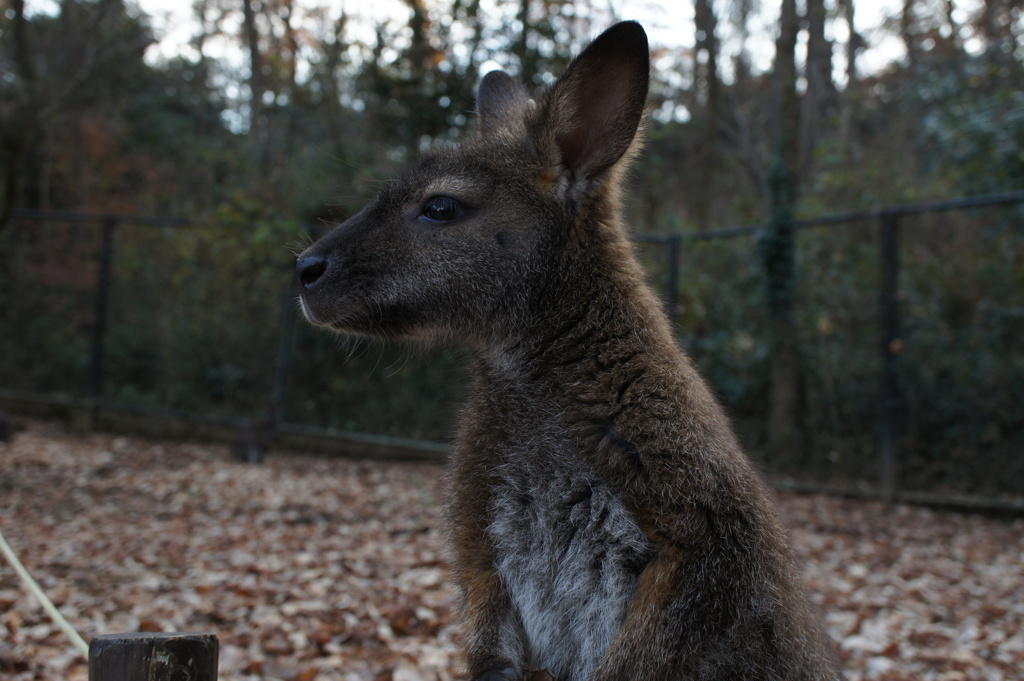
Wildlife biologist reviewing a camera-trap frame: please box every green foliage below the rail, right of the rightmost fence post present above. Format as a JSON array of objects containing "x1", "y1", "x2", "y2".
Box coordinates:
[{"x1": 900, "y1": 207, "x2": 1024, "y2": 492}]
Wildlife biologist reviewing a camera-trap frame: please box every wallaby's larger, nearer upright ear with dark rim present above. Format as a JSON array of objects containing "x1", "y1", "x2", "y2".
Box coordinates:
[{"x1": 549, "y1": 22, "x2": 650, "y2": 177}]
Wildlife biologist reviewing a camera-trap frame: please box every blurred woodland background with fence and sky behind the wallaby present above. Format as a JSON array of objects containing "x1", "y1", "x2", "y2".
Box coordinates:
[{"x1": 0, "y1": 0, "x2": 1024, "y2": 504}]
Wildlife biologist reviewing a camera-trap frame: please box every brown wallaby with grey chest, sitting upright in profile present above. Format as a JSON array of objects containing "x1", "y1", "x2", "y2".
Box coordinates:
[{"x1": 296, "y1": 22, "x2": 841, "y2": 681}]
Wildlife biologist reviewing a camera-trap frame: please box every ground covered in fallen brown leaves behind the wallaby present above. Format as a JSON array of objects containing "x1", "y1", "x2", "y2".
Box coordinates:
[{"x1": 0, "y1": 422, "x2": 1024, "y2": 681}]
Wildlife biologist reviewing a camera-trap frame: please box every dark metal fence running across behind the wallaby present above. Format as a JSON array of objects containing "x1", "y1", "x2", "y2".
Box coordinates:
[{"x1": 0, "y1": 191, "x2": 1024, "y2": 504}]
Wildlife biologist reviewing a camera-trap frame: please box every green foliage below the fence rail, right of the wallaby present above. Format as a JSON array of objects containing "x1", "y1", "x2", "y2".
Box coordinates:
[{"x1": 640, "y1": 207, "x2": 1024, "y2": 495}]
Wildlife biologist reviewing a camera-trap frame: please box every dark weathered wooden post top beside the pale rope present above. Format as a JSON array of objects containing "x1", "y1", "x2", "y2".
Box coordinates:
[{"x1": 89, "y1": 633, "x2": 219, "y2": 681}]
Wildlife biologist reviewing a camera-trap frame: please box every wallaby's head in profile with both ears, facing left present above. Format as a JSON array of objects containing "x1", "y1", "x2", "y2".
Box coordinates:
[{"x1": 297, "y1": 22, "x2": 649, "y2": 345}]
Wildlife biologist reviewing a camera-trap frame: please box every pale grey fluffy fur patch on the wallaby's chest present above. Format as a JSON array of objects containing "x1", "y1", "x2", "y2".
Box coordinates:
[{"x1": 488, "y1": 457, "x2": 652, "y2": 680}]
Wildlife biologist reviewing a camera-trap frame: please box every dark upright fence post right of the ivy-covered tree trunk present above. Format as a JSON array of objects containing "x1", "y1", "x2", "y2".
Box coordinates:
[{"x1": 879, "y1": 210, "x2": 903, "y2": 502}]
